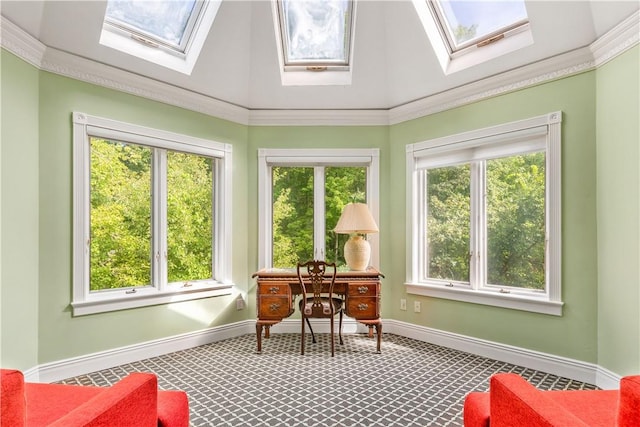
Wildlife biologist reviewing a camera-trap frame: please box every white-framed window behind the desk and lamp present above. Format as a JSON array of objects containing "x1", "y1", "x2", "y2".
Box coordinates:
[{"x1": 259, "y1": 149, "x2": 379, "y2": 268}]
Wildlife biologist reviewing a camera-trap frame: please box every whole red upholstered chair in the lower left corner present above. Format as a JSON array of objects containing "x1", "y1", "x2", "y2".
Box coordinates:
[{"x1": 0, "y1": 369, "x2": 189, "y2": 427}]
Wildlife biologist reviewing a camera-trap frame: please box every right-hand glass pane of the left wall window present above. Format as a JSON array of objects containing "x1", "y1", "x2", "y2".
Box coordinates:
[{"x1": 167, "y1": 151, "x2": 214, "y2": 283}]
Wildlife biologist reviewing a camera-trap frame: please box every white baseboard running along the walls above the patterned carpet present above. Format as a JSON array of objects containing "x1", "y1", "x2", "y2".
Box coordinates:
[{"x1": 24, "y1": 318, "x2": 620, "y2": 389}]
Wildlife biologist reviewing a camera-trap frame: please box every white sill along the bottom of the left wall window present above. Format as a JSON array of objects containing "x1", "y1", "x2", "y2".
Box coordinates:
[{"x1": 71, "y1": 284, "x2": 233, "y2": 317}]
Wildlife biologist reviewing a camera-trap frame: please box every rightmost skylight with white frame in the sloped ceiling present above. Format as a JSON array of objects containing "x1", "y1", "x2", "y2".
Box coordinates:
[{"x1": 413, "y1": 0, "x2": 533, "y2": 74}]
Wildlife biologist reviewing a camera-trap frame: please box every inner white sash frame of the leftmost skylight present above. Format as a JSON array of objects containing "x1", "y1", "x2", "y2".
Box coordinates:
[{"x1": 103, "y1": 0, "x2": 207, "y2": 55}]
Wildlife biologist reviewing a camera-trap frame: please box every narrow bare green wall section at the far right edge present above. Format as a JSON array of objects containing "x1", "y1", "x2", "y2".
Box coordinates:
[{"x1": 596, "y1": 46, "x2": 640, "y2": 375}]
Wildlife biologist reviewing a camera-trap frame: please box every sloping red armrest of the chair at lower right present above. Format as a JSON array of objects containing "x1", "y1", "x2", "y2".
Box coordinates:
[{"x1": 489, "y1": 374, "x2": 588, "y2": 427}]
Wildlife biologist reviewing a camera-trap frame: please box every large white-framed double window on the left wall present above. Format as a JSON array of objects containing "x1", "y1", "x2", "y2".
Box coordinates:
[{"x1": 72, "y1": 113, "x2": 231, "y2": 315}]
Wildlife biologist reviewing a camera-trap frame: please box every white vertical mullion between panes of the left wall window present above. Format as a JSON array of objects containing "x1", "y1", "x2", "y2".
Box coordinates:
[{"x1": 151, "y1": 148, "x2": 168, "y2": 291}]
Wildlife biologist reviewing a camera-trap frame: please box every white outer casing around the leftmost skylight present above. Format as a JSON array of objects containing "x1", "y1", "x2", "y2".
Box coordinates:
[{"x1": 100, "y1": 0, "x2": 222, "y2": 75}]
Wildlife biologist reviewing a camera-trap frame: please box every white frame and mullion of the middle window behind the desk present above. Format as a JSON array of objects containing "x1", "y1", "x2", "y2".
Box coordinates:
[{"x1": 258, "y1": 148, "x2": 380, "y2": 268}]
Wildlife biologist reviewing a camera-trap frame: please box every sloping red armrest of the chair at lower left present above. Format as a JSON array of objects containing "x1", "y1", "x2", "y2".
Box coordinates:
[{"x1": 50, "y1": 373, "x2": 158, "y2": 427}]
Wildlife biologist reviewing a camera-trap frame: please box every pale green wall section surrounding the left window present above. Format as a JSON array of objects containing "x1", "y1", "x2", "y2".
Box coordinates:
[{"x1": 33, "y1": 64, "x2": 250, "y2": 364}]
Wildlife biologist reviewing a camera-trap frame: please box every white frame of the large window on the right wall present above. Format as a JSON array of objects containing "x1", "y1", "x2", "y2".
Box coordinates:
[{"x1": 405, "y1": 111, "x2": 563, "y2": 316}]
